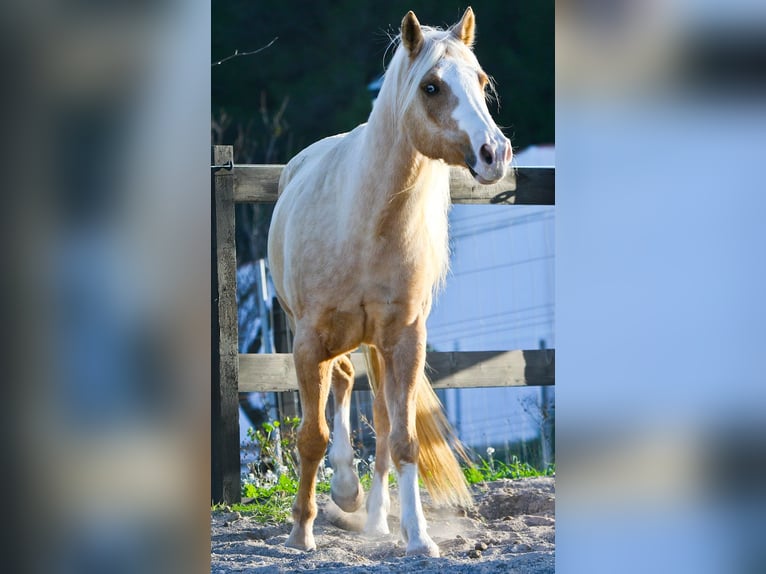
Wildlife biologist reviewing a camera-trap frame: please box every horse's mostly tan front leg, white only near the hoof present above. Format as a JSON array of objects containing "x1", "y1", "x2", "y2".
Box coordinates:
[{"x1": 285, "y1": 329, "x2": 332, "y2": 550}]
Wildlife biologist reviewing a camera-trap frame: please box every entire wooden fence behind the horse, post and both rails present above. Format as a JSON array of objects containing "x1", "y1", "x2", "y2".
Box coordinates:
[{"x1": 211, "y1": 146, "x2": 555, "y2": 503}]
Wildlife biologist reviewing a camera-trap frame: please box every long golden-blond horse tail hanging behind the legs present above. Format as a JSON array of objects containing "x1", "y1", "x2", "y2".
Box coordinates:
[{"x1": 362, "y1": 345, "x2": 473, "y2": 506}]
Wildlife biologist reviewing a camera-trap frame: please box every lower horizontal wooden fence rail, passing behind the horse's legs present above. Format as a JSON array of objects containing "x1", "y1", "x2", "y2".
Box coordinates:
[{"x1": 239, "y1": 349, "x2": 556, "y2": 392}]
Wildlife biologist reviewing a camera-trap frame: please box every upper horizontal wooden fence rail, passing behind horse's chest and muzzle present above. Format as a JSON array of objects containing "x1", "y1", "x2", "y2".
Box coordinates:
[{"x1": 234, "y1": 165, "x2": 556, "y2": 205}]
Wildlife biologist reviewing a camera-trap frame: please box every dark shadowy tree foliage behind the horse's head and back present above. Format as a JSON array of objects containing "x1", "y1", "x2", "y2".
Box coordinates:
[{"x1": 211, "y1": 0, "x2": 554, "y2": 261}]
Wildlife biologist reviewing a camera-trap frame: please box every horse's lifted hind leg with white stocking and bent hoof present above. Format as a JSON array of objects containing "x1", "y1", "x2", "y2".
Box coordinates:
[{"x1": 329, "y1": 355, "x2": 364, "y2": 512}]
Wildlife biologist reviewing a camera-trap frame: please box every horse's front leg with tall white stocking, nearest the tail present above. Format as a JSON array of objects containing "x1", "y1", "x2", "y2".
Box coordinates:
[{"x1": 384, "y1": 319, "x2": 439, "y2": 556}]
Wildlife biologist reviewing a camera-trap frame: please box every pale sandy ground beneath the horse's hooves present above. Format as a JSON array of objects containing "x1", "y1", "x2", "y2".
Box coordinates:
[{"x1": 211, "y1": 477, "x2": 555, "y2": 574}]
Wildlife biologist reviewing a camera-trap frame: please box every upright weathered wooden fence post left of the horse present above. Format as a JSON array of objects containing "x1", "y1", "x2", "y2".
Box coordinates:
[{"x1": 210, "y1": 146, "x2": 240, "y2": 504}]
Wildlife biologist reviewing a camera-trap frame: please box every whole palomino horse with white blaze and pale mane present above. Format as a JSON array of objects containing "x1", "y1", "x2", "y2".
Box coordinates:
[{"x1": 269, "y1": 8, "x2": 511, "y2": 556}]
